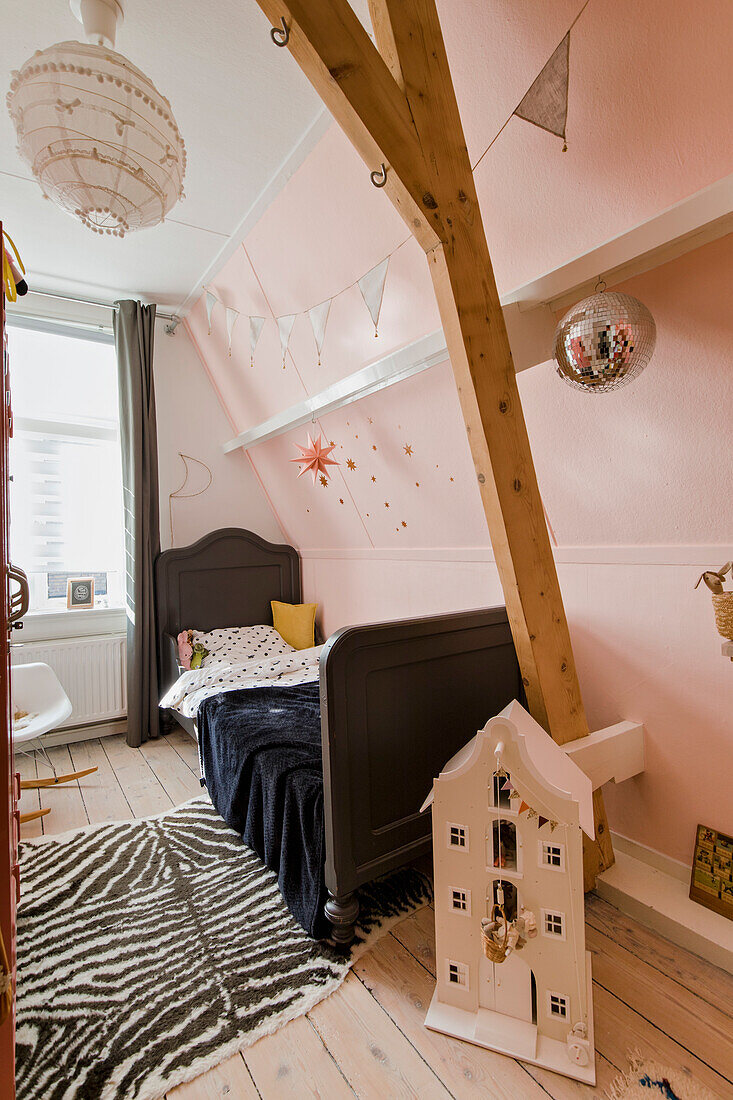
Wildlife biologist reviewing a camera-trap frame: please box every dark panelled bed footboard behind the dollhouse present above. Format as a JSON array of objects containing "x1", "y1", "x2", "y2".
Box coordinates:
[{"x1": 320, "y1": 607, "x2": 524, "y2": 938}]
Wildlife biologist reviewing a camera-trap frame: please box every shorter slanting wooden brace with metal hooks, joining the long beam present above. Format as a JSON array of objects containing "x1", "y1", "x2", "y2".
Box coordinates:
[{"x1": 256, "y1": 0, "x2": 439, "y2": 250}]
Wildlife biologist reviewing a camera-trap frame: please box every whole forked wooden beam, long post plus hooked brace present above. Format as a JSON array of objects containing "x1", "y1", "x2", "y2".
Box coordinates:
[{"x1": 250, "y1": 0, "x2": 613, "y2": 888}]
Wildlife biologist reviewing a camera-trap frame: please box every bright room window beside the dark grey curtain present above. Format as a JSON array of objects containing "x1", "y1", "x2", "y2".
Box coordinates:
[{"x1": 9, "y1": 318, "x2": 124, "y2": 612}]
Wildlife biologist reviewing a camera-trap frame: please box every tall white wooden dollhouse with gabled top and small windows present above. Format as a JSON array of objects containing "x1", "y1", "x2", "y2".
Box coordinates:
[{"x1": 423, "y1": 702, "x2": 595, "y2": 1085}]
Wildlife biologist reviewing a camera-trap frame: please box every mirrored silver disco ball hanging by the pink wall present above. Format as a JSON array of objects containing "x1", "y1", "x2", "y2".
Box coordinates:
[{"x1": 555, "y1": 290, "x2": 657, "y2": 394}]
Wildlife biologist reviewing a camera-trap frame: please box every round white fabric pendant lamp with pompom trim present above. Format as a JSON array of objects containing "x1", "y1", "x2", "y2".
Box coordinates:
[{"x1": 7, "y1": 0, "x2": 186, "y2": 237}]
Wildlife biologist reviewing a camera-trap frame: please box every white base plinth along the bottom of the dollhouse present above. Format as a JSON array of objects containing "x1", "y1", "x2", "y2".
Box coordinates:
[{"x1": 425, "y1": 952, "x2": 595, "y2": 1085}]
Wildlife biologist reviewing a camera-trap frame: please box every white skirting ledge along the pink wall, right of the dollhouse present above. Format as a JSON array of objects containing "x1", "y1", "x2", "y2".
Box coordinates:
[{"x1": 595, "y1": 838, "x2": 733, "y2": 974}]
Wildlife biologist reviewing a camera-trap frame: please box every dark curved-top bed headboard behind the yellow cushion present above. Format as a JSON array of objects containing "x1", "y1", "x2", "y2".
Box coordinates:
[{"x1": 155, "y1": 527, "x2": 300, "y2": 684}]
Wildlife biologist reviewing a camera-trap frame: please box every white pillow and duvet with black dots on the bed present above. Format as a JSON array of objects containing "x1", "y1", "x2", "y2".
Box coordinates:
[{"x1": 161, "y1": 626, "x2": 324, "y2": 718}]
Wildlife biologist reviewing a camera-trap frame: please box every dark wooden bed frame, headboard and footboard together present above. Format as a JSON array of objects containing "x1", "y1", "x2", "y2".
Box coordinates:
[{"x1": 155, "y1": 528, "x2": 523, "y2": 943}]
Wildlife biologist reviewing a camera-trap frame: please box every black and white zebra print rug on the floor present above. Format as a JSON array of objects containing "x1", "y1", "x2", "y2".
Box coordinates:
[{"x1": 17, "y1": 798, "x2": 430, "y2": 1100}]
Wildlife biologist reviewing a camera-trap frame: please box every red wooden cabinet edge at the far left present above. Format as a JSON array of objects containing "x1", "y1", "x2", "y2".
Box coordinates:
[{"x1": 0, "y1": 226, "x2": 20, "y2": 1100}]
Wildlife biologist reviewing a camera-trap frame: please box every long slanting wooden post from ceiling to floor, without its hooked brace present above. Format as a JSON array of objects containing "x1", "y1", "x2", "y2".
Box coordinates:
[{"x1": 370, "y1": 0, "x2": 613, "y2": 886}]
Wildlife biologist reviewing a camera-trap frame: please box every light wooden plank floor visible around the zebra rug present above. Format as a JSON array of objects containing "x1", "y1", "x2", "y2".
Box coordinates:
[{"x1": 15, "y1": 729, "x2": 733, "y2": 1100}]
